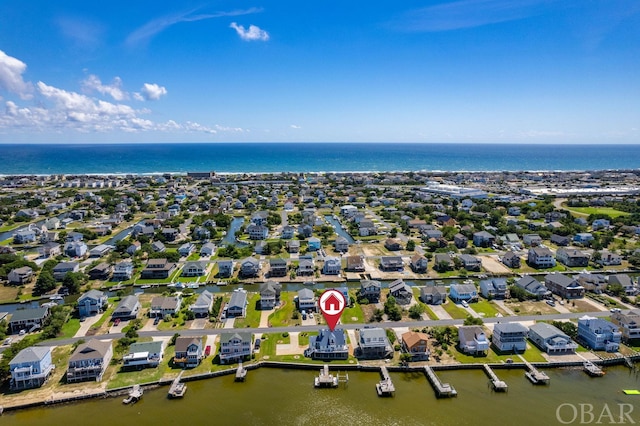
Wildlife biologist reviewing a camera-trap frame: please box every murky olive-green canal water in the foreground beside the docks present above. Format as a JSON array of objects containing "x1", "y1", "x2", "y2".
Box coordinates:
[{"x1": 2, "y1": 367, "x2": 640, "y2": 426}]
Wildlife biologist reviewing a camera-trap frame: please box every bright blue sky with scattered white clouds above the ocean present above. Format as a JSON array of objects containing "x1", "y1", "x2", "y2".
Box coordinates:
[{"x1": 0, "y1": 0, "x2": 640, "y2": 143}]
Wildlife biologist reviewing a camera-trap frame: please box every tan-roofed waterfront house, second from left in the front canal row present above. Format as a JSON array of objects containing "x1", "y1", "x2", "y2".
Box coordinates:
[{"x1": 66, "y1": 339, "x2": 113, "y2": 383}]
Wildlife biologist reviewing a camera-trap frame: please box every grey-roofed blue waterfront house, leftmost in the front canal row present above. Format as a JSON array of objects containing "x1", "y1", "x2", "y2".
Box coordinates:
[{"x1": 9, "y1": 346, "x2": 55, "y2": 389}]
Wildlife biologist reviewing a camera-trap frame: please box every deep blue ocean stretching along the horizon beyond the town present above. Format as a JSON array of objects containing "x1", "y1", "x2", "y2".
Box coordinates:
[{"x1": 0, "y1": 143, "x2": 640, "y2": 175}]
